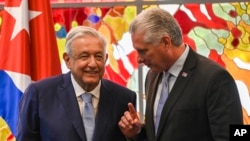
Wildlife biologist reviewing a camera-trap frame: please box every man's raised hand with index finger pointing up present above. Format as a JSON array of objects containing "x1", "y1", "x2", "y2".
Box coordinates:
[{"x1": 119, "y1": 103, "x2": 142, "y2": 139}]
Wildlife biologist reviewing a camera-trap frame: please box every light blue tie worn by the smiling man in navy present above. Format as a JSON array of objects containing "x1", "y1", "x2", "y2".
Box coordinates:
[{"x1": 82, "y1": 93, "x2": 95, "y2": 141}]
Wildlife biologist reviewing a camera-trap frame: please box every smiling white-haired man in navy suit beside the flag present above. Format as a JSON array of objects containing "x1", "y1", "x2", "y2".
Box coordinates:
[{"x1": 17, "y1": 26, "x2": 136, "y2": 141}]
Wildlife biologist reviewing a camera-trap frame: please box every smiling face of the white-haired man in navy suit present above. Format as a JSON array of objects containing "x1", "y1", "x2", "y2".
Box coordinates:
[{"x1": 63, "y1": 36, "x2": 107, "y2": 91}]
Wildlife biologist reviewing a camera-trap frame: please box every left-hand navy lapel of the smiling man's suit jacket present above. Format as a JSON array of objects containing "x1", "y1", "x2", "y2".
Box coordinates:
[{"x1": 57, "y1": 73, "x2": 86, "y2": 141}]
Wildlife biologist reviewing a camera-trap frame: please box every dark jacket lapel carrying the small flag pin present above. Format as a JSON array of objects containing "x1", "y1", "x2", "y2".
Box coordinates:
[{"x1": 157, "y1": 48, "x2": 197, "y2": 138}]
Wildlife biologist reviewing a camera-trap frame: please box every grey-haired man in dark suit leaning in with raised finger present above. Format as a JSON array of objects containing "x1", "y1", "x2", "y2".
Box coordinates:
[{"x1": 119, "y1": 8, "x2": 243, "y2": 141}]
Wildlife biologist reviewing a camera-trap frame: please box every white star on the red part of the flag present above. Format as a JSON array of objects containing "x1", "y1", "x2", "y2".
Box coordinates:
[{"x1": 4, "y1": 0, "x2": 42, "y2": 40}]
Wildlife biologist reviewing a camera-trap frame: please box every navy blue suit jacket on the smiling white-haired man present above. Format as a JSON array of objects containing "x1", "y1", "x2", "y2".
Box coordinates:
[{"x1": 17, "y1": 73, "x2": 136, "y2": 141}]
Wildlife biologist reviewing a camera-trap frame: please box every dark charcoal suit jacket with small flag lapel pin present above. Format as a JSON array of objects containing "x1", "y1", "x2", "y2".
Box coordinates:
[{"x1": 141, "y1": 48, "x2": 243, "y2": 141}]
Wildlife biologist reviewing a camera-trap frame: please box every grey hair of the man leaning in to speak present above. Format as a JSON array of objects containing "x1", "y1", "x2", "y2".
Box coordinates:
[{"x1": 129, "y1": 8, "x2": 183, "y2": 46}]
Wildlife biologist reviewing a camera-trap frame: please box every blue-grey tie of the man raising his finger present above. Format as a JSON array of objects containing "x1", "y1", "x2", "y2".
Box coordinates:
[{"x1": 155, "y1": 73, "x2": 171, "y2": 133}]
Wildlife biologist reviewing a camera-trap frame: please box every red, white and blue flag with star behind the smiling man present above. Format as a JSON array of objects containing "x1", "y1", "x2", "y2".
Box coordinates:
[{"x1": 0, "y1": 0, "x2": 61, "y2": 136}]
